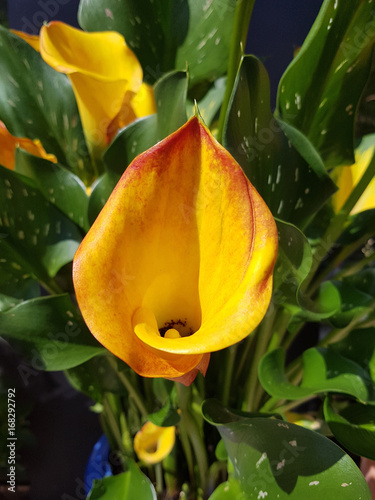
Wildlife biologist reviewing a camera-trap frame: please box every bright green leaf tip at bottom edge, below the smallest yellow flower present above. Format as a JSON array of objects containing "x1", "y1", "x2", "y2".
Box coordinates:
[{"x1": 87, "y1": 460, "x2": 156, "y2": 500}]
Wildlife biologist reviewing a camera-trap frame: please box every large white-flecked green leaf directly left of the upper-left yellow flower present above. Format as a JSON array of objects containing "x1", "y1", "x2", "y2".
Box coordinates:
[{"x1": 0, "y1": 26, "x2": 95, "y2": 184}]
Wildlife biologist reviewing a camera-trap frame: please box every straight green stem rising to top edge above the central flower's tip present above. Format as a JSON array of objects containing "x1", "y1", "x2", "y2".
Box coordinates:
[{"x1": 217, "y1": 0, "x2": 255, "y2": 143}]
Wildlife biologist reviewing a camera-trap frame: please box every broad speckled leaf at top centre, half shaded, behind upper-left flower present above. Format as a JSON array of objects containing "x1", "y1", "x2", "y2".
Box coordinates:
[{"x1": 78, "y1": 0, "x2": 235, "y2": 84}]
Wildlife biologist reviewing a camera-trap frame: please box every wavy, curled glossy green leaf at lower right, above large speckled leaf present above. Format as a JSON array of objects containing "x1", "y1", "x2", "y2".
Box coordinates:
[{"x1": 259, "y1": 347, "x2": 374, "y2": 402}]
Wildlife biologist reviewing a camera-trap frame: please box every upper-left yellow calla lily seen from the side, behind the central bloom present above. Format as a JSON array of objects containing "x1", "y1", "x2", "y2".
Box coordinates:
[{"x1": 40, "y1": 21, "x2": 156, "y2": 154}]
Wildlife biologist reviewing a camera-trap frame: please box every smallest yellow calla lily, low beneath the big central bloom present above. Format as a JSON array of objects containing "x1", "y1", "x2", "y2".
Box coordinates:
[{"x1": 134, "y1": 422, "x2": 176, "y2": 465}]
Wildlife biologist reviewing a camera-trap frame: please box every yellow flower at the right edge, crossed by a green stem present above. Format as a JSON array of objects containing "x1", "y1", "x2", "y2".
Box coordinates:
[{"x1": 332, "y1": 140, "x2": 375, "y2": 215}]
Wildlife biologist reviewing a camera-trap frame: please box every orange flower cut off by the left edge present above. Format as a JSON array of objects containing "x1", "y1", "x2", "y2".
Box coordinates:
[{"x1": 0, "y1": 121, "x2": 57, "y2": 170}]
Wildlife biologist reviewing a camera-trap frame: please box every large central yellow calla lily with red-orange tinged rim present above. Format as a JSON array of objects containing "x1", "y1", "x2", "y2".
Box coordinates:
[{"x1": 73, "y1": 117, "x2": 277, "y2": 384}]
